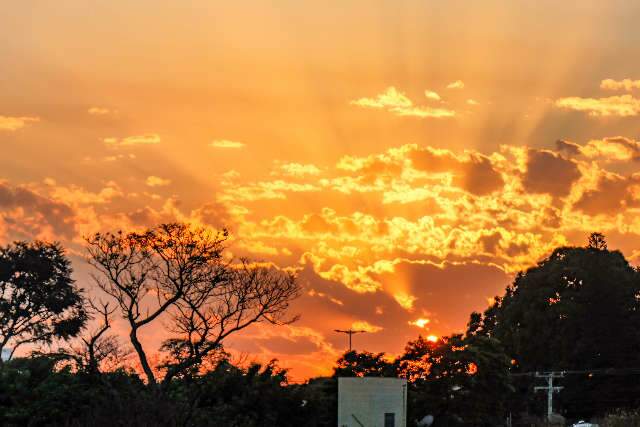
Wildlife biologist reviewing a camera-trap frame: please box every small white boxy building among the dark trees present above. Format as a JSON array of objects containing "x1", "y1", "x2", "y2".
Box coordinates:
[{"x1": 338, "y1": 377, "x2": 407, "y2": 427}]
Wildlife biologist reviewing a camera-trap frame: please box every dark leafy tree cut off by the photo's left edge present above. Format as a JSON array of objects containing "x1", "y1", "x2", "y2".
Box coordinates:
[{"x1": 0, "y1": 241, "x2": 87, "y2": 363}]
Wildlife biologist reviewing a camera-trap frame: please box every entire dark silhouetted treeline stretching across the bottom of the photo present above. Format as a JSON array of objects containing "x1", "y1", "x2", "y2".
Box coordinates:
[{"x1": 0, "y1": 224, "x2": 640, "y2": 427}]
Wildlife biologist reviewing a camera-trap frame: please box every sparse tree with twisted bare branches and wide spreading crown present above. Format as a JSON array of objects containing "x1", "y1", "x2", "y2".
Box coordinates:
[{"x1": 87, "y1": 223, "x2": 300, "y2": 388}]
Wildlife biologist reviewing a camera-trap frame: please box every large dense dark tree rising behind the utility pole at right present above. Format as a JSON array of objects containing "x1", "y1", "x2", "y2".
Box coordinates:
[{"x1": 469, "y1": 233, "x2": 640, "y2": 416}]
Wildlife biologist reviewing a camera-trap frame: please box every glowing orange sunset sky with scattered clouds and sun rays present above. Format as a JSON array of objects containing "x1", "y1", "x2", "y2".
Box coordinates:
[{"x1": 0, "y1": 0, "x2": 640, "y2": 380}]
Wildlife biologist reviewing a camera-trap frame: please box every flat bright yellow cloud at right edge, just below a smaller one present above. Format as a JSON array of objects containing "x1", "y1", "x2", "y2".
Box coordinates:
[{"x1": 555, "y1": 95, "x2": 640, "y2": 117}]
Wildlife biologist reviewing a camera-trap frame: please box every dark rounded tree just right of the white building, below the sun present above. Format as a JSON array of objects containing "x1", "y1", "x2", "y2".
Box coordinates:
[{"x1": 396, "y1": 335, "x2": 512, "y2": 426}]
